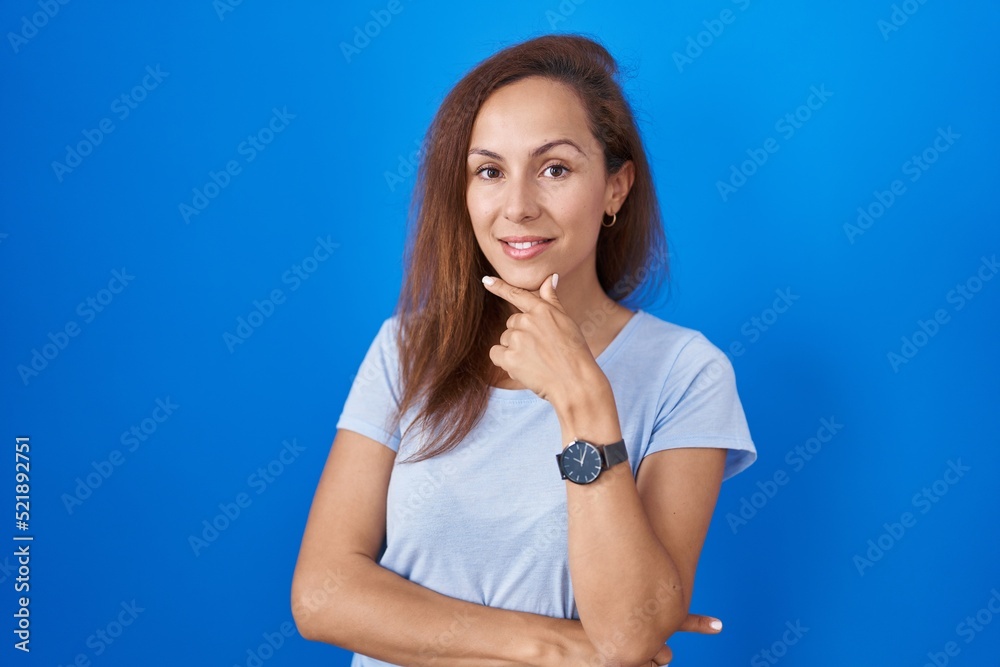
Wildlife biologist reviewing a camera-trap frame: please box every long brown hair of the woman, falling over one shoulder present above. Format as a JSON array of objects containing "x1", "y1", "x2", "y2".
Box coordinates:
[{"x1": 396, "y1": 35, "x2": 668, "y2": 461}]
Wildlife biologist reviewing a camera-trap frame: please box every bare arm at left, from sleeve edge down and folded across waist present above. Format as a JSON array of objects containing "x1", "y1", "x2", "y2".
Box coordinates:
[{"x1": 292, "y1": 430, "x2": 620, "y2": 667}]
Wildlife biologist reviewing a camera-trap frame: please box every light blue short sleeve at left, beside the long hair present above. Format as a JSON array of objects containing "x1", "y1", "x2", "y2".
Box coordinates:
[{"x1": 337, "y1": 317, "x2": 400, "y2": 451}]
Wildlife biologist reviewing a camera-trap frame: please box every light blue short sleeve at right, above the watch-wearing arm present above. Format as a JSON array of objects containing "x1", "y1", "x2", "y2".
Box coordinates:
[{"x1": 642, "y1": 333, "x2": 757, "y2": 480}]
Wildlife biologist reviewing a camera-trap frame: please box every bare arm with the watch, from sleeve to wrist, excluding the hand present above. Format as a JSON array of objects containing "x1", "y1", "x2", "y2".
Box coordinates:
[{"x1": 554, "y1": 374, "x2": 726, "y2": 665}]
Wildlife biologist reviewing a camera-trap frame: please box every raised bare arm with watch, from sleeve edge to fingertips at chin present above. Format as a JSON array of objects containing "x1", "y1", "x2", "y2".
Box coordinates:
[{"x1": 483, "y1": 276, "x2": 726, "y2": 665}]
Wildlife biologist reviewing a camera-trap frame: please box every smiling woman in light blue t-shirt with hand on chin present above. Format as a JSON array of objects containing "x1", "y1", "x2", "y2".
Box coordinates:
[{"x1": 292, "y1": 36, "x2": 756, "y2": 665}]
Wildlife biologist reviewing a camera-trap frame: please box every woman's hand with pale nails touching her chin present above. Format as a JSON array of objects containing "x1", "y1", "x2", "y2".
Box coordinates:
[{"x1": 483, "y1": 274, "x2": 606, "y2": 404}]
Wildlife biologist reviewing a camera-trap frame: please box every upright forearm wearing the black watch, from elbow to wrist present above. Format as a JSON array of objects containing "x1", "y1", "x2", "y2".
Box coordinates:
[{"x1": 555, "y1": 376, "x2": 689, "y2": 665}]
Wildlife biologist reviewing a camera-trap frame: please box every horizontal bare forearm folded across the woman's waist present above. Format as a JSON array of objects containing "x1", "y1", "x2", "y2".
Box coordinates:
[{"x1": 292, "y1": 554, "x2": 586, "y2": 667}]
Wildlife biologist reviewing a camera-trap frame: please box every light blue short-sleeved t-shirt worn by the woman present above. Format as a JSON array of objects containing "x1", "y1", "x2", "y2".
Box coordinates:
[{"x1": 337, "y1": 310, "x2": 757, "y2": 667}]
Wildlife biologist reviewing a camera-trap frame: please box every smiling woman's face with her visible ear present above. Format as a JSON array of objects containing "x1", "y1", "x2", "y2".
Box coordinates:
[{"x1": 466, "y1": 77, "x2": 631, "y2": 291}]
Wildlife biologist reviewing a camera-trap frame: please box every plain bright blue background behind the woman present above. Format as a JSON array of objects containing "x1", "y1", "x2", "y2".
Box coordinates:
[{"x1": 0, "y1": 0, "x2": 1000, "y2": 666}]
